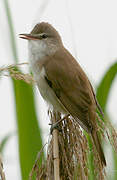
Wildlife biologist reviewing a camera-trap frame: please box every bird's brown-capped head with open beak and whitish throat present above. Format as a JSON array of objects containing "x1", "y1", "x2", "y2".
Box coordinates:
[{"x1": 20, "y1": 22, "x2": 62, "y2": 56}]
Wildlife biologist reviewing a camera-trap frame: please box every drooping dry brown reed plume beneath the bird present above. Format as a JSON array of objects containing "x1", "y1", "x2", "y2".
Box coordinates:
[{"x1": 29, "y1": 111, "x2": 106, "y2": 180}]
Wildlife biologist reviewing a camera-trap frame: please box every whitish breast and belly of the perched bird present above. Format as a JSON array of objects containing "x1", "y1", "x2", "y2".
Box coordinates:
[{"x1": 29, "y1": 43, "x2": 66, "y2": 114}]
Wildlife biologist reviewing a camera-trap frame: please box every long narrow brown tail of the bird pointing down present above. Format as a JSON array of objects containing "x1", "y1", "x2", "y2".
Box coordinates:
[{"x1": 91, "y1": 129, "x2": 106, "y2": 166}]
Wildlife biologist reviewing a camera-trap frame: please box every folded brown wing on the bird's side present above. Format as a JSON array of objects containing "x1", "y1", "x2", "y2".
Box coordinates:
[{"x1": 44, "y1": 49, "x2": 93, "y2": 132}]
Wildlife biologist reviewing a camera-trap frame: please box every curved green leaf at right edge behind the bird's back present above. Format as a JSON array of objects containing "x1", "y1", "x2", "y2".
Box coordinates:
[{"x1": 96, "y1": 62, "x2": 117, "y2": 112}]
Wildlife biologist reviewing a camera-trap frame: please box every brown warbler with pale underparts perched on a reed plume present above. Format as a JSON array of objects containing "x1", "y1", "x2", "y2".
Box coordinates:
[{"x1": 20, "y1": 22, "x2": 106, "y2": 166}]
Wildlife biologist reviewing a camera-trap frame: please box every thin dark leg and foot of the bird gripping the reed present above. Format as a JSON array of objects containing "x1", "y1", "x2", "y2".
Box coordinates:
[{"x1": 49, "y1": 114, "x2": 70, "y2": 134}]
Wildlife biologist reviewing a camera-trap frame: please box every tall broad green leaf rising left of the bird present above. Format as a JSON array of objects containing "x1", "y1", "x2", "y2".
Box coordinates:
[{"x1": 3, "y1": 0, "x2": 42, "y2": 180}]
